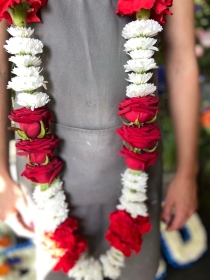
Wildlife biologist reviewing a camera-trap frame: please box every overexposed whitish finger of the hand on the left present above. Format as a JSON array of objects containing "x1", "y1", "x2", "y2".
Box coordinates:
[{"x1": 5, "y1": 213, "x2": 35, "y2": 238}]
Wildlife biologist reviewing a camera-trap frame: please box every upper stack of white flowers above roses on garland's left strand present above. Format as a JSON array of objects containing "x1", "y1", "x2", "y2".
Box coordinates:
[{"x1": 4, "y1": 26, "x2": 50, "y2": 110}]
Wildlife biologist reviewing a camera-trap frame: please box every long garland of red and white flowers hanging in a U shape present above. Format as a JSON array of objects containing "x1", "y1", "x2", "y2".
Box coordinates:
[{"x1": 0, "y1": 0, "x2": 172, "y2": 280}]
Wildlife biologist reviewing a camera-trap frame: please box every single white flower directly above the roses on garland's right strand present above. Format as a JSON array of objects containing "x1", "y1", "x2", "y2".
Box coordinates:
[{"x1": 126, "y1": 84, "x2": 156, "y2": 98}]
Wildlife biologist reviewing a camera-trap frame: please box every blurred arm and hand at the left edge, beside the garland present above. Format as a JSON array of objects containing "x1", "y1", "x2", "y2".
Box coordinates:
[{"x1": 0, "y1": 21, "x2": 32, "y2": 237}]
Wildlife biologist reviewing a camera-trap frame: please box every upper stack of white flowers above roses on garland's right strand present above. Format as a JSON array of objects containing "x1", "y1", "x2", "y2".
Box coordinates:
[{"x1": 122, "y1": 19, "x2": 163, "y2": 98}]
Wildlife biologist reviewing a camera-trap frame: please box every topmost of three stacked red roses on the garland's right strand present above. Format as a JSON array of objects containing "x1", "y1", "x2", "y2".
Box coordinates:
[{"x1": 118, "y1": 96, "x2": 159, "y2": 123}]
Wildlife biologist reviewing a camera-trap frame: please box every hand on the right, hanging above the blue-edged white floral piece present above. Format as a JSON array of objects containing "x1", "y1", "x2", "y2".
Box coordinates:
[{"x1": 161, "y1": 174, "x2": 198, "y2": 231}]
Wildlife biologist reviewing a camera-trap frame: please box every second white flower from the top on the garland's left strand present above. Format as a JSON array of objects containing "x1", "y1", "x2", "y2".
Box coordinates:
[{"x1": 4, "y1": 37, "x2": 43, "y2": 55}]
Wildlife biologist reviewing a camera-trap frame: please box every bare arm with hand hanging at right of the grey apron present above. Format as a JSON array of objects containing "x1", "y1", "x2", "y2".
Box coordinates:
[{"x1": 162, "y1": 0, "x2": 200, "y2": 231}]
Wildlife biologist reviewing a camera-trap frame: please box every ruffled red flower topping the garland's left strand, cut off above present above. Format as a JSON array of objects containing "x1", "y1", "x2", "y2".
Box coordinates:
[{"x1": 0, "y1": 0, "x2": 47, "y2": 24}]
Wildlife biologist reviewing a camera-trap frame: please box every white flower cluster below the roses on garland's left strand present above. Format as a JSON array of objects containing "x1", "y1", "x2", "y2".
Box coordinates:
[{"x1": 33, "y1": 181, "x2": 69, "y2": 232}]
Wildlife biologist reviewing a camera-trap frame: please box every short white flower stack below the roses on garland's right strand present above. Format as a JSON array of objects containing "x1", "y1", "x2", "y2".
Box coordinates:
[{"x1": 117, "y1": 169, "x2": 148, "y2": 219}]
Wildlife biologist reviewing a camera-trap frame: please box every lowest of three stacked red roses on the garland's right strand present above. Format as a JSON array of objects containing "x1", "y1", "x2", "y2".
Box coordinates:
[{"x1": 119, "y1": 144, "x2": 159, "y2": 171}]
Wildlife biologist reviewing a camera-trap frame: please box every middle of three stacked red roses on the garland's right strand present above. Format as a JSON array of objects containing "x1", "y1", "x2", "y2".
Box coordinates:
[{"x1": 117, "y1": 123, "x2": 161, "y2": 149}]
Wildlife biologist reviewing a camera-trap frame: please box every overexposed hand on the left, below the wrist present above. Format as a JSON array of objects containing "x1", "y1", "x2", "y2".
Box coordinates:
[{"x1": 0, "y1": 176, "x2": 34, "y2": 238}]
